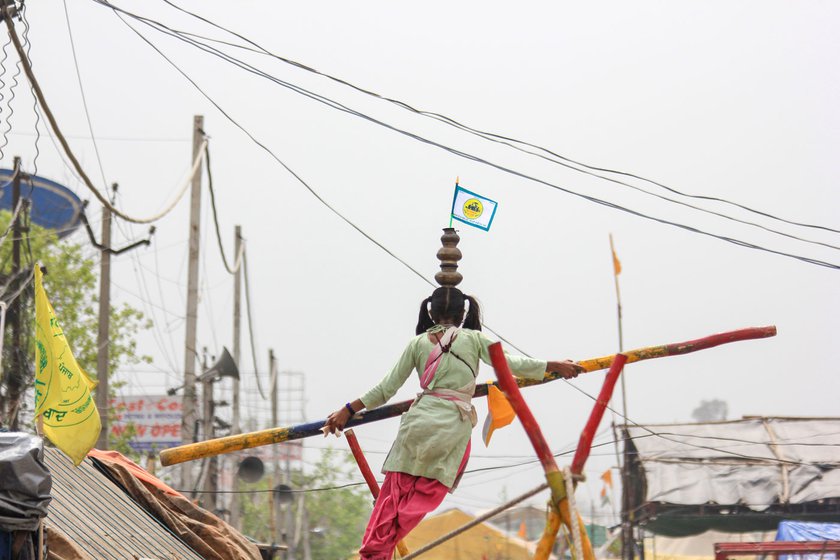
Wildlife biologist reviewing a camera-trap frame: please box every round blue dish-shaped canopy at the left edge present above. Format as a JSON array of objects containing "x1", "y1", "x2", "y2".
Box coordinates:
[{"x1": 0, "y1": 169, "x2": 83, "y2": 241}]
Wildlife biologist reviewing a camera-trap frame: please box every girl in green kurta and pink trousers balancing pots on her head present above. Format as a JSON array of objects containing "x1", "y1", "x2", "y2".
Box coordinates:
[{"x1": 323, "y1": 284, "x2": 582, "y2": 560}]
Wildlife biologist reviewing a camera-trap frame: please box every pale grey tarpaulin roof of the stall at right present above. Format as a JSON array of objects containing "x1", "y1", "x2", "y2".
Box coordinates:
[{"x1": 624, "y1": 417, "x2": 840, "y2": 532}]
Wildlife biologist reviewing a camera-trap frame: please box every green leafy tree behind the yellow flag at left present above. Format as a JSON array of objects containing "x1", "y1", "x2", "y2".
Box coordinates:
[{"x1": 0, "y1": 211, "x2": 151, "y2": 438}]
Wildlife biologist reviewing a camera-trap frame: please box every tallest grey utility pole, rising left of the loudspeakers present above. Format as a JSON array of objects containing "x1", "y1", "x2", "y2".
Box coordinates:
[{"x1": 181, "y1": 115, "x2": 204, "y2": 489}]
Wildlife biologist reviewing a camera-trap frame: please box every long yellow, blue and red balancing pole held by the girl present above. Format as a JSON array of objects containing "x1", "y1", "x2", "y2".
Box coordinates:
[{"x1": 160, "y1": 326, "x2": 776, "y2": 466}]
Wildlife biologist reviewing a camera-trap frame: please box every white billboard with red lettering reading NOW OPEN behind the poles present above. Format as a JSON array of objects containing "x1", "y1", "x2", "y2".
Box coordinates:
[{"x1": 110, "y1": 395, "x2": 183, "y2": 451}]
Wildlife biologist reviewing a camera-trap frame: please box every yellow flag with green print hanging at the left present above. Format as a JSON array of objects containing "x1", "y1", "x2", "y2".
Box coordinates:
[{"x1": 35, "y1": 265, "x2": 102, "y2": 466}]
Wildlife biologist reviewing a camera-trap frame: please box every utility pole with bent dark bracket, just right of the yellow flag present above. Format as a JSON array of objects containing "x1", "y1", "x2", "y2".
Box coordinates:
[{"x1": 96, "y1": 195, "x2": 117, "y2": 449}]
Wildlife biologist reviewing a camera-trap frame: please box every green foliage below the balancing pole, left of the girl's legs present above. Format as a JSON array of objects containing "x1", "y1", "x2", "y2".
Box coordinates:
[{"x1": 241, "y1": 450, "x2": 372, "y2": 559}]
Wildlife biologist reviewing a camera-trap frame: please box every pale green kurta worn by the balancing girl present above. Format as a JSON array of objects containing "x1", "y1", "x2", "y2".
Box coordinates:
[{"x1": 361, "y1": 329, "x2": 546, "y2": 488}]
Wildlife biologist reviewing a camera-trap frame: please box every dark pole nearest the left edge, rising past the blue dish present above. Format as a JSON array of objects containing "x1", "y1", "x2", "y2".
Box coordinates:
[{"x1": 7, "y1": 156, "x2": 24, "y2": 431}]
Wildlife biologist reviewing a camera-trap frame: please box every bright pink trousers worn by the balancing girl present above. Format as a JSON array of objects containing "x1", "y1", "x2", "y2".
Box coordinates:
[{"x1": 359, "y1": 443, "x2": 470, "y2": 560}]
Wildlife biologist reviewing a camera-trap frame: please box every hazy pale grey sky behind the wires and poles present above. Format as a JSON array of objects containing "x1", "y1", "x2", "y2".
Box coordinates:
[{"x1": 2, "y1": 0, "x2": 840, "y2": 524}]
